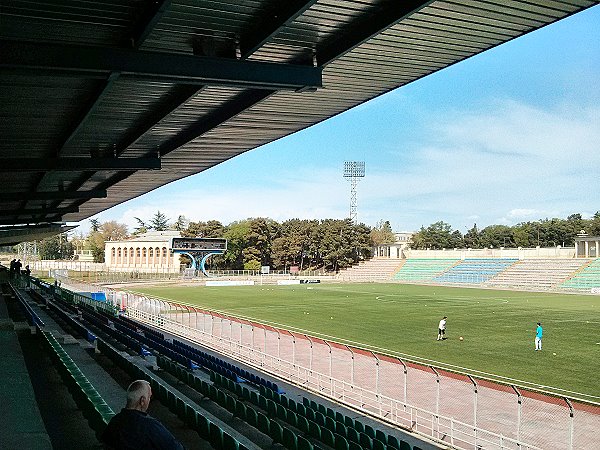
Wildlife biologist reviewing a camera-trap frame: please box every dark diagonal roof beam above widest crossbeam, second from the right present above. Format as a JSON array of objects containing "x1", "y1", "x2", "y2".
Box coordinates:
[{"x1": 240, "y1": 0, "x2": 318, "y2": 59}]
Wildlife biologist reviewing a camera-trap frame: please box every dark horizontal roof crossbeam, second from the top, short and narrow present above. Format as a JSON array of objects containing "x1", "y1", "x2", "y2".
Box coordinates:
[{"x1": 0, "y1": 158, "x2": 161, "y2": 172}]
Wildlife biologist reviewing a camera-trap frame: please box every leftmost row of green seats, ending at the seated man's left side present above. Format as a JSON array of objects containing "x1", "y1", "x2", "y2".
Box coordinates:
[{"x1": 42, "y1": 331, "x2": 115, "y2": 436}]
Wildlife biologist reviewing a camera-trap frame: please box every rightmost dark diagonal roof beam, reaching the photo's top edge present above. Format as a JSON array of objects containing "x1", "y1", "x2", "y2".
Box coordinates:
[{"x1": 316, "y1": 0, "x2": 435, "y2": 67}]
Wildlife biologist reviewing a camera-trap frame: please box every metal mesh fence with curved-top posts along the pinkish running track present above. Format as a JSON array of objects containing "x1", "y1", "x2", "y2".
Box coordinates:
[{"x1": 38, "y1": 279, "x2": 600, "y2": 450}]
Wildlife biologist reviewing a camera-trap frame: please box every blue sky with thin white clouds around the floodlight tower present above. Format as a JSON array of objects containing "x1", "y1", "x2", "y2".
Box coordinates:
[{"x1": 79, "y1": 6, "x2": 600, "y2": 233}]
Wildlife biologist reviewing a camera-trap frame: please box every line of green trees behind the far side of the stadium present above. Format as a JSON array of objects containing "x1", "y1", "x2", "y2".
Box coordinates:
[{"x1": 29, "y1": 211, "x2": 600, "y2": 271}]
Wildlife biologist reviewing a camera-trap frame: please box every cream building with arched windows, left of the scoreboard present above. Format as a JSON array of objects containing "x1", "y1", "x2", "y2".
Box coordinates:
[{"x1": 104, "y1": 231, "x2": 181, "y2": 272}]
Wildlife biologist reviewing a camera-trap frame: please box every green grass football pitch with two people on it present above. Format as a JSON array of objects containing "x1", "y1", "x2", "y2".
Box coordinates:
[{"x1": 131, "y1": 283, "x2": 600, "y2": 401}]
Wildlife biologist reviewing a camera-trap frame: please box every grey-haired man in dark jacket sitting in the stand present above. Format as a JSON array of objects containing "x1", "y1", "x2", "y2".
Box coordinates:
[{"x1": 101, "y1": 380, "x2": 183, "y2": 450}]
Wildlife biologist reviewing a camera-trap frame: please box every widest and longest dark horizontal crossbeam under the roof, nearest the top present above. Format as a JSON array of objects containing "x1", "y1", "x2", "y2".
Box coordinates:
[{"x1": 0, "y1": 40, "x2": 322, "y2": 90}]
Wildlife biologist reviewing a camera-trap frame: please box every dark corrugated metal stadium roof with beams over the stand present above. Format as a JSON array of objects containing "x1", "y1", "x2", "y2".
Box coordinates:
[{"x1": 0, "y1": 0, "x2": 598, "y2": 243}]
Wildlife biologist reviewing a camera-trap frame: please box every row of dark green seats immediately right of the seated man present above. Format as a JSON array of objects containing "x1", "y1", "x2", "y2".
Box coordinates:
[{"x1": 98, "y1": 339, "x2": 247, "y2": 450}]
